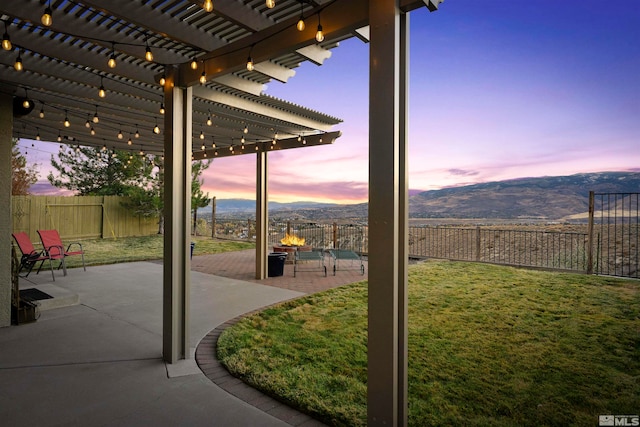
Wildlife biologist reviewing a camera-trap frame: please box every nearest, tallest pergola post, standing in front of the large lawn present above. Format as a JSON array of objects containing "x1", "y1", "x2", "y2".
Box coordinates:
[{"x1": 367, "y1": 0, "x2": 408, "y2": 426}]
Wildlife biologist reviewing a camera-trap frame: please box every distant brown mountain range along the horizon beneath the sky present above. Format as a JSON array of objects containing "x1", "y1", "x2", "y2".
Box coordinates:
[{"x1": 208, "y1": 172, "x2": 640, "y2": 221}]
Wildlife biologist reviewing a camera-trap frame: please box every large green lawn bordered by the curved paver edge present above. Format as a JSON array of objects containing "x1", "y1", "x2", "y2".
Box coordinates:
[{"x1": 218, "y1": 261, "x2": 640, "y2": 426}]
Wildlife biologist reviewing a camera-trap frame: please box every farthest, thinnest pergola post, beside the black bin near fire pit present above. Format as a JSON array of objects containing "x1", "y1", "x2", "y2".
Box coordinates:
[{"x1": 256, "y1": 150, "x2": 269, "y2": 280}]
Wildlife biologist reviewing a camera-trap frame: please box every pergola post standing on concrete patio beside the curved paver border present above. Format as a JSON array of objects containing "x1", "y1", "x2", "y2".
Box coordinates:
[{"x1": 162, "y1": 77, "x2": 193, "y2": 363}]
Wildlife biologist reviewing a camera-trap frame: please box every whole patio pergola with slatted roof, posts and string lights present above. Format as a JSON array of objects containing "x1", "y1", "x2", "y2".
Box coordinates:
[{"x1": 0, "y1": 0, "x2": 442, "y2": 425}]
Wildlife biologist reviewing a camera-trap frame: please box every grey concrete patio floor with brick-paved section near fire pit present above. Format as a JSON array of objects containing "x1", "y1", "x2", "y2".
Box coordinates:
[{"x1": 0, "y1": 251, "x2": 366, "y2": 427}]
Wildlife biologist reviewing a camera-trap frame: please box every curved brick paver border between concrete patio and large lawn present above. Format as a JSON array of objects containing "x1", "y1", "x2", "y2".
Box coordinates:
[{"x1": 196, "y1": 307, "x2": 326, "y2": 427}]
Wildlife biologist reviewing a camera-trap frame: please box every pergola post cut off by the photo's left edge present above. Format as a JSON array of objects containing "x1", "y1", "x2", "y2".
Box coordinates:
[{"x1": 0, "y1": 93, "x2": 13, "y2": 327}]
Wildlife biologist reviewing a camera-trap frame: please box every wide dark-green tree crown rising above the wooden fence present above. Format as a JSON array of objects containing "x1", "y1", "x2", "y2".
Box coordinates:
[{"x1": 47, "y1": 146, "x2": 152, "y2": 196}]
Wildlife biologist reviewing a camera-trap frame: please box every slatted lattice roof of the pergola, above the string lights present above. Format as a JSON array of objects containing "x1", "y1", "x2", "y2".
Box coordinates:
[{"x1": 0, "y1": 0, "x2": 358, "y2": 154}]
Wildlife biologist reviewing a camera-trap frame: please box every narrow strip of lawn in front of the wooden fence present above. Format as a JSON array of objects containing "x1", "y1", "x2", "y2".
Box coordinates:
[{"x1": 57, "y1": 234, "x2": 255, "y2": 267}]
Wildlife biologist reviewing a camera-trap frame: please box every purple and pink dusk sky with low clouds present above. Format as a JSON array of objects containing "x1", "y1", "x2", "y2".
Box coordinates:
[{"x1": 21, "y1": 0, "x2": 640, "y2": 203}]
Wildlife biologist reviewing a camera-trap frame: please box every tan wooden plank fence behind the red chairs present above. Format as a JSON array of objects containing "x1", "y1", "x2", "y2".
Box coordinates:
[{"x1": 11, "y1": 196, "x2": 158, "y2": 241}]
